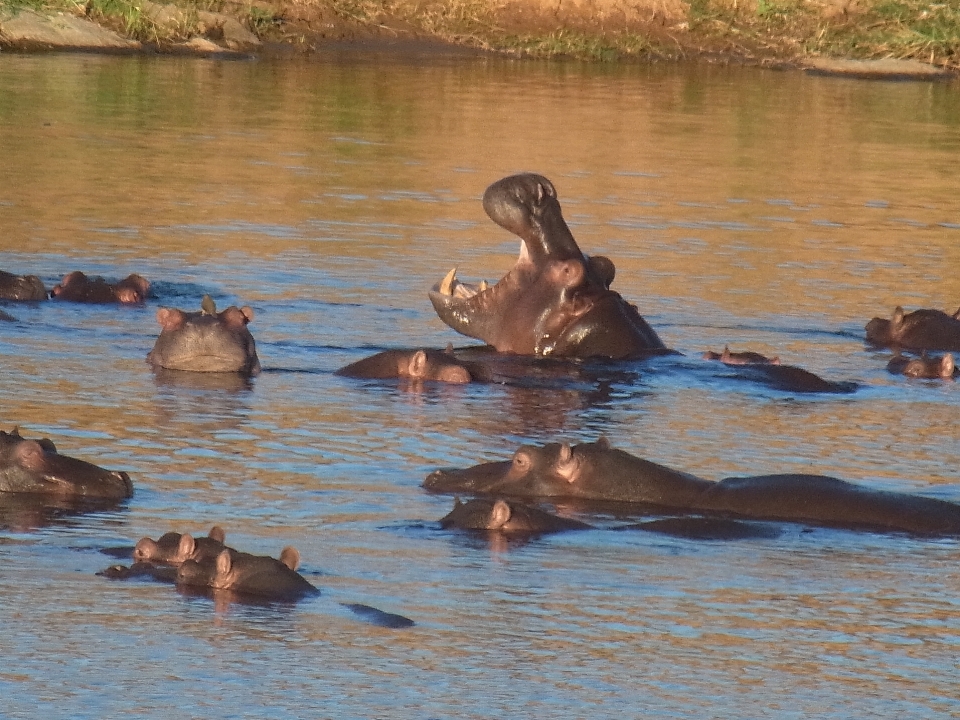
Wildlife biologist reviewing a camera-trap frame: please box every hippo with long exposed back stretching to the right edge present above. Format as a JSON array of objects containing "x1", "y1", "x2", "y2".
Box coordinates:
[{"x1": 423, "y1": 438, "x2": 960, "y2": 535}]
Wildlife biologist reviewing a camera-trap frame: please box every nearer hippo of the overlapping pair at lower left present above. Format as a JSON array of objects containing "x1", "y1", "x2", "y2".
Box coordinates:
[{"x1": 177, "y1": 546, "x2": 320, "y2": 602}]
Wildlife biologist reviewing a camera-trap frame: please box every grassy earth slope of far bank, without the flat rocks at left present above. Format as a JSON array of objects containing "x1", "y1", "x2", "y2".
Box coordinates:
[{"x1": 0, "y1": 0, "x2": 960, "y2": 69}]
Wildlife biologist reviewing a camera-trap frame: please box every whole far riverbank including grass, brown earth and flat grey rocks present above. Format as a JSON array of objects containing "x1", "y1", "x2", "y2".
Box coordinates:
[{"x1": 0, "y1": 0, "x2": 960, "y2": 73}]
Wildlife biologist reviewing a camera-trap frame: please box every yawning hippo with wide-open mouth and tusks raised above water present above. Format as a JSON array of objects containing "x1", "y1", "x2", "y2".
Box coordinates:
[{"x1": 429, "y1": 173, "x2": 670, "y2": 360}]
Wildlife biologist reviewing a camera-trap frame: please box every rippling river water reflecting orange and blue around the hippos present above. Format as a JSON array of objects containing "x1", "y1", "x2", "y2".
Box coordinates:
[{"x1": 0, "y1": 49, "x2": 960, "y2": 718}]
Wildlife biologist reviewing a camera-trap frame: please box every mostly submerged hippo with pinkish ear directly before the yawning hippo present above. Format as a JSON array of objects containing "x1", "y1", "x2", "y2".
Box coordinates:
[{"x1": 336, "y1": 348, "x2": 489, "y2": 383}]
